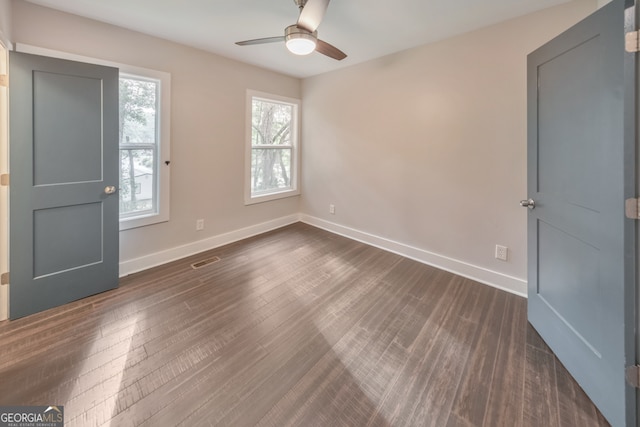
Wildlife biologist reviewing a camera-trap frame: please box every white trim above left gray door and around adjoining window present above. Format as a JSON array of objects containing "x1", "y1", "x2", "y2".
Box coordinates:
[{"x1": 16, "y1": 43, "x2": 171, "y2": 231}]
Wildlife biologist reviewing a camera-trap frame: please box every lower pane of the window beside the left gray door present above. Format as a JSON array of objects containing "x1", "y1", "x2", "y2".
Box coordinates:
[{"x1": 119, "y1": 148, "x2": 155, "y2": 215}]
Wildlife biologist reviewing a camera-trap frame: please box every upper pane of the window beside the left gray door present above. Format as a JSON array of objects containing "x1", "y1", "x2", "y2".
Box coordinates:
[{"x1": 120, "y1": 78, "x2": 158, "y2": 144}]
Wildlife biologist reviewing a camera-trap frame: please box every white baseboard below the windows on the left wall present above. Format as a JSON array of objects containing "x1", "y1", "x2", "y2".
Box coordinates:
[{"x1": 120, "y1": 214, "x2": 300, "y2": 277}]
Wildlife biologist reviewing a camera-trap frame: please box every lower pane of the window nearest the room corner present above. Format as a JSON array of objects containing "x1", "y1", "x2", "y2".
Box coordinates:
[{"x1": 251, "y1": 148, "x2": 291, "y2": 194}]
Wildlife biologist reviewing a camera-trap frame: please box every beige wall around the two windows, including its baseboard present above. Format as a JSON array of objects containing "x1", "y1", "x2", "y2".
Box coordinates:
[{"x1": 12, "y1": 1, "x2": 301, "y2": 273}]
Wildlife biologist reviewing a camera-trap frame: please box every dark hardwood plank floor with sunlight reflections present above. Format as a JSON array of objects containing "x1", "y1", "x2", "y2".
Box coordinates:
[{"x1": 0, "y1": 223, "x2": 608, "y2": 427}]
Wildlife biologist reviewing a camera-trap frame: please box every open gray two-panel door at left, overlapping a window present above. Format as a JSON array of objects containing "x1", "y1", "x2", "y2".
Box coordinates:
[{"x1": 9, "y1": 52, "x2": 119, "y2": 319}]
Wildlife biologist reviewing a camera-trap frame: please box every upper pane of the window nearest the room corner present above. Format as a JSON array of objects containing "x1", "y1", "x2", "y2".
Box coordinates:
[{"x1": 251, "y1": 98, "x2": 293, "y2": 145}]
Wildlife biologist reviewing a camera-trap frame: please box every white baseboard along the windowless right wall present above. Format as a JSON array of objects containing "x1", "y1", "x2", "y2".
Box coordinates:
[{"x1": 300, "y1": 214, "x2": 527, "y2": 297}]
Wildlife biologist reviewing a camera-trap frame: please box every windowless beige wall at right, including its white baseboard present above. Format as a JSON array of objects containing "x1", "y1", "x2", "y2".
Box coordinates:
[{"x1": 301, "y1": 0, "x2": 596, "y2": 293}]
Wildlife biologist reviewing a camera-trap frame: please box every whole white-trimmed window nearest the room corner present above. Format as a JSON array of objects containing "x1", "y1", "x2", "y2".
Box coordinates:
[{"x1": 245, "y1": 91, "x2": 300, "y2": 204}]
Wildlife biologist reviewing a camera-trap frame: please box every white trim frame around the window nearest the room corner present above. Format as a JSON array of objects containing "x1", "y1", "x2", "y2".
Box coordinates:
[{"x1": 244, "y1": 89, "x2": 302, "y2": 205}]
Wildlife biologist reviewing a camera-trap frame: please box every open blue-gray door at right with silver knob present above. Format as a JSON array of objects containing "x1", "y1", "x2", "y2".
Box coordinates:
[{"x1": 527, "y1": 0, "x2": 636, "y2": 426}]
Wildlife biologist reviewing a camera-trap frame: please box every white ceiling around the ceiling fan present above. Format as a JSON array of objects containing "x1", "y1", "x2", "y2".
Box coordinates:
[{"x1": 23, "y1": 0, "x2": 569, "y2": 78}]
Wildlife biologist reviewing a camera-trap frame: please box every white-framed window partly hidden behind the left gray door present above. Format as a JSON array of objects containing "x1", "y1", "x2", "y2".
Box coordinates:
[{"x1": 119, "y1": 72, "x2": 169, "y2": 230}]
